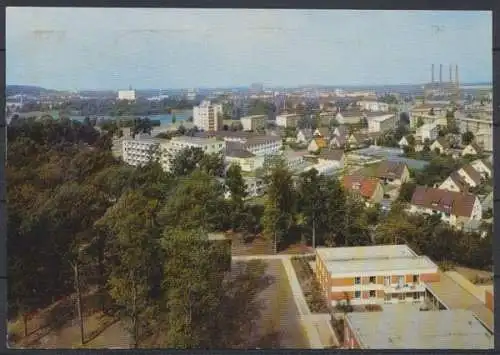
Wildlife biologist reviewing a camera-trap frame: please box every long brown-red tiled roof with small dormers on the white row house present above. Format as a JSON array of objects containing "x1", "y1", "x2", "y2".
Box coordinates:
[{"x1": 411, "y1": 186, "x2": 477, "y2": 217}]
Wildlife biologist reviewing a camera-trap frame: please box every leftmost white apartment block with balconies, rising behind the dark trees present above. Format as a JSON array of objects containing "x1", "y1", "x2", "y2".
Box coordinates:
[{"x1": 121, "y1": 136, "x2": 162, "y2": 166}]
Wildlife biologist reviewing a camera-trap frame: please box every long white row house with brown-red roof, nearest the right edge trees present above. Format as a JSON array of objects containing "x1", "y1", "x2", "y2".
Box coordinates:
[{"x1": 408, "y1": 186, "x2": 482, "y2": 228}]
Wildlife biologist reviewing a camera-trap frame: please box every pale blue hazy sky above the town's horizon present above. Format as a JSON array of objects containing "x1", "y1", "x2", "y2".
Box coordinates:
[{"x1": 6, "y1": 7, "x2": 493, "y2": 90}]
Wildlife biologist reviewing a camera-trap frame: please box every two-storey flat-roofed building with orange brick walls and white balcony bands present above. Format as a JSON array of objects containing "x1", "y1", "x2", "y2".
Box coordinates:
[{"x1": 316, "y1": 245, "x2": 439, "y2": 306}]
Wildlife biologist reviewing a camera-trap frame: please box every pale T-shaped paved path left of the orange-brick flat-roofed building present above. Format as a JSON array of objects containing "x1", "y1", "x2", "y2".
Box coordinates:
[{"x1": 232, "y1": 254, "x2": 338, "y2": 349}]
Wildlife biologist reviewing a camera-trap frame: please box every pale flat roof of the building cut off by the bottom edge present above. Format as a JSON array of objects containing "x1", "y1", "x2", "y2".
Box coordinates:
[{"x1": 344, "y1": 307, "x2": 494, "y2": 349}]
